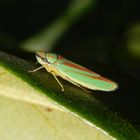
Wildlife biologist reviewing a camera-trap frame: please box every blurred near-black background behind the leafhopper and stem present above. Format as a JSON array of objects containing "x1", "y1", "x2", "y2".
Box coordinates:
[{"x1": 0, "y1": 0, "x2": 140, "y2": 130}]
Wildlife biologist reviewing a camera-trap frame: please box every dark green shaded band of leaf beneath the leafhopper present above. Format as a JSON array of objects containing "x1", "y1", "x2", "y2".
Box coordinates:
[{"x1": 0, "y1": 52, "x2": 139, "y2": 140}]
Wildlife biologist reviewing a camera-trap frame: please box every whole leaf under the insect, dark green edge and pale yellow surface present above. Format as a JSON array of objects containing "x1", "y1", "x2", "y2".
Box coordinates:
[{"x1": 0, "y1": 52, "x2": 140, "y2": 140}]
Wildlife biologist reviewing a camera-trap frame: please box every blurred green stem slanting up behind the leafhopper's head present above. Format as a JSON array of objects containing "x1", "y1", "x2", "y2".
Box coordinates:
[{"x1": 21, "y1": 0, "x2": 95, "y2": 52}]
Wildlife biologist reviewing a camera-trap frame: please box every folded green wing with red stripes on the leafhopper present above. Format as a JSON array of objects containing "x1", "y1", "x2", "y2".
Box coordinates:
[{"x1": 56, "y1": 57, "x2": 117, "y2": 91}]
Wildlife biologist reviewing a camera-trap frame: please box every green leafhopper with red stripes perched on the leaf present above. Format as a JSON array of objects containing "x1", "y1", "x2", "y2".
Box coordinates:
[{"x1": 31, "y1": 51, "x2": 118, "y2": 91}]
